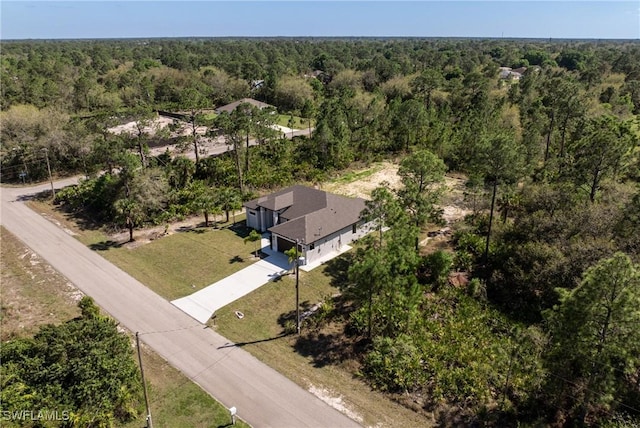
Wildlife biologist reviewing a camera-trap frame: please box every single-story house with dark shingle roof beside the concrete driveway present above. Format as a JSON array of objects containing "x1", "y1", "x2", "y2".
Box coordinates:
[{"x1": 244, "y1": 185, "x2": 373, "y2": 264}]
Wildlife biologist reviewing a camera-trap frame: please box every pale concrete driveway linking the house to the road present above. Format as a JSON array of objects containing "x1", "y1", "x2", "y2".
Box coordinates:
[{"x1": 171, "y1": 238, "x2": 291, "y2": 324}]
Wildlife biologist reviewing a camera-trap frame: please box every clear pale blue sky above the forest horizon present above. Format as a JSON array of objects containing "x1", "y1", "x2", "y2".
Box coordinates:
[{"x1": 0, "y1": 0, "x2": 640, "y2": 40}]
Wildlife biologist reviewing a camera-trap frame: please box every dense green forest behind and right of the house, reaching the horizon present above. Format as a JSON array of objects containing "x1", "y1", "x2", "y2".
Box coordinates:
[{"x1": 0, "y1": 38, "x2": 640, "y2": 426}]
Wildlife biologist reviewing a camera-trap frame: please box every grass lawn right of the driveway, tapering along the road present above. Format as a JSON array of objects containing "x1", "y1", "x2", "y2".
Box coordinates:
[{"x1": 210, "y1": 260, "x2": 434, "y2": 427}]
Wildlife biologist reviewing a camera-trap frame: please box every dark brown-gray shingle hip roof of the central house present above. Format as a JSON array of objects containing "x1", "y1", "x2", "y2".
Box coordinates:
[{"x1": 245, "y1": 185, "x2": 365, "y2": 243}]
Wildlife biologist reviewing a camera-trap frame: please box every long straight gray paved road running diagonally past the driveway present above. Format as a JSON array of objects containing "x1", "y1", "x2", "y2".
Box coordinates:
[{"x1": 0, "y1": 184, "x2": 358, "y2": 427}]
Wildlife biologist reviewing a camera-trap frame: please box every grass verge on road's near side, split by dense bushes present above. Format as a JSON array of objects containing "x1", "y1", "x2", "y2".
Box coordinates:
[{"x1": 0, "y1": 227, "x2": 248, "y2": 428}]
